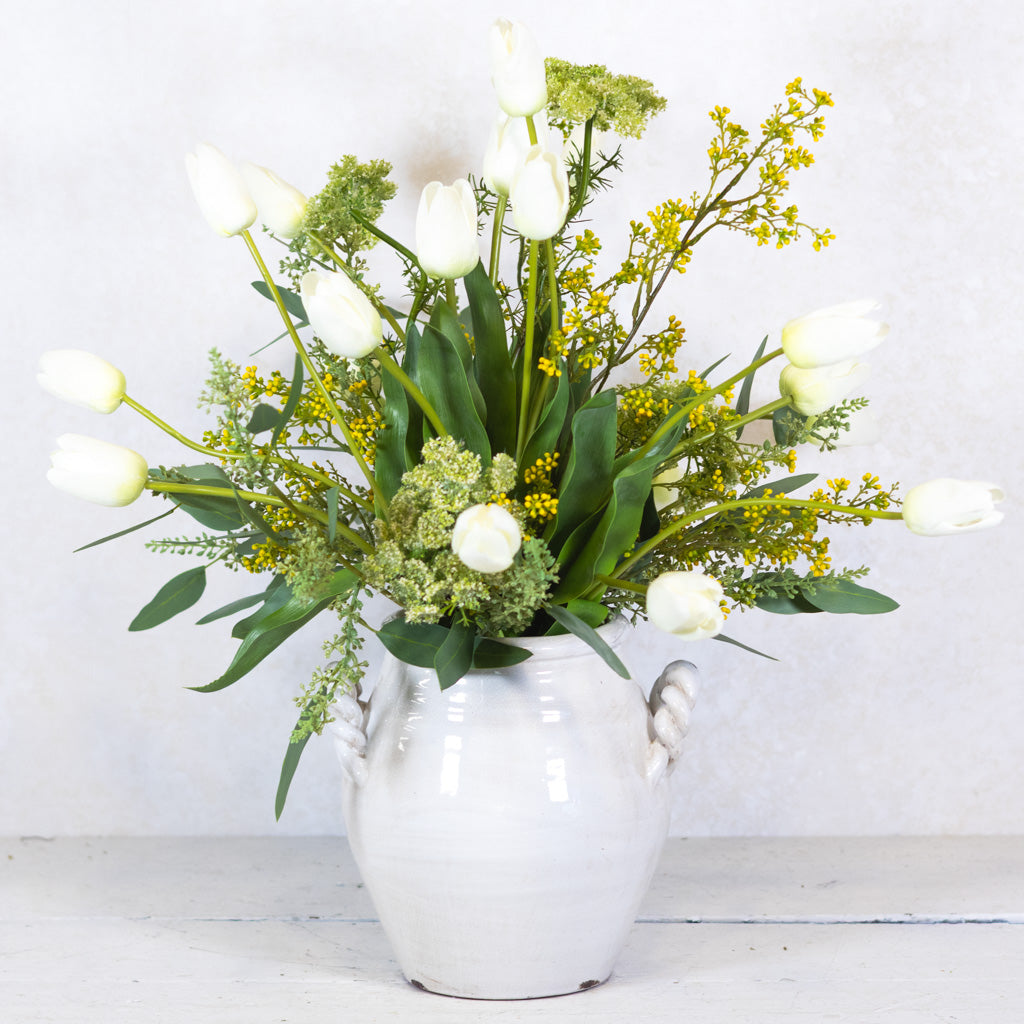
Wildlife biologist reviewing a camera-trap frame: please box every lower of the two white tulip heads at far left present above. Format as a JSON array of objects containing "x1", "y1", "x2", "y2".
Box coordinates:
[{"x1": 46, "y1": 434, "x2": 150, "y2": 507}]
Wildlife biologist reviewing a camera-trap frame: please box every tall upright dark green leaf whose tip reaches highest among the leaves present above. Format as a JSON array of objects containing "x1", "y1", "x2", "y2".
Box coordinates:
[{"x1": 463, "y1": 263, "x2": 516, "y2": 455}]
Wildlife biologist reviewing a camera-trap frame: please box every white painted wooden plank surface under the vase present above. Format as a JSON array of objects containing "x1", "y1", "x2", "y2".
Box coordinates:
[{"x1": 0, "y1": 837, "x2": 1024, "y2": 1024}]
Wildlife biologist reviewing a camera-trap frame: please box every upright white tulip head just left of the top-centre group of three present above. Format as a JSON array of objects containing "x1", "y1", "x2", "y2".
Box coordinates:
[{"x1": 416, "y1": 178, "x2": 480, "y2": 281}]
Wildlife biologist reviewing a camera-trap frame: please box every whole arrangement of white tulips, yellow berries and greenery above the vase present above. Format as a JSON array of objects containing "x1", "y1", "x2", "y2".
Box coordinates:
[{"x1": 39, "y1": 19, "x2": 1002, "y2": 815}]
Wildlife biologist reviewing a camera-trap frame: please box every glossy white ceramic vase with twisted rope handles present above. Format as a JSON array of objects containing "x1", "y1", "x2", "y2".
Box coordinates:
[{"x1": 332, "y1": 621, "x2": 696, "y2": 999}]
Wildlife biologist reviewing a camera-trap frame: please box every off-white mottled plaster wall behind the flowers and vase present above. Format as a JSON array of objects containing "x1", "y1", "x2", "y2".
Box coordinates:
[{"x1": 0, "y1": 0, "x2": 1024, "y2": 836}]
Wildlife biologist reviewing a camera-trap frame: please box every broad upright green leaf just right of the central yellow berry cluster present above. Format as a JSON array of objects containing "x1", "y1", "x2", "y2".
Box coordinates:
[{"x1": 550, "y1": 391, "x2": 616, "y2": 551}]
